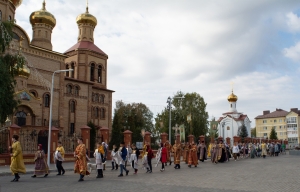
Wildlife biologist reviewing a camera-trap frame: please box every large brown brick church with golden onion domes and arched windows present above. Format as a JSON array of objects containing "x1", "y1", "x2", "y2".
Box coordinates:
[{"x1": 0, "y1": 0, "x2": 114, "y2": 142}]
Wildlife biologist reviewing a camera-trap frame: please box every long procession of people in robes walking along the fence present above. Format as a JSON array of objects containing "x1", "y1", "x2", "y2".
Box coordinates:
[{"x1": 10, "y1": 135, "x2": 286, "y2": 182}]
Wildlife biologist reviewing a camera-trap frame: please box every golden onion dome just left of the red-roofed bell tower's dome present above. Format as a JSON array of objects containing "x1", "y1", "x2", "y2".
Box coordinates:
[{"x1": 29, "y1": 0, "x2": 56, "y2": 27}]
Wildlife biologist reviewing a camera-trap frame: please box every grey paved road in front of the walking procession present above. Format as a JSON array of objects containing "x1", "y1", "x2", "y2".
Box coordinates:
[{"x1": 0, "y1": 155, "x2": 300, "y2": 192}]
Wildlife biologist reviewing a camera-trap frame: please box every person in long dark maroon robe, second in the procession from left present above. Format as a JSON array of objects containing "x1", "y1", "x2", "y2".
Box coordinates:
[{"x1": 31, "y1": 144, "x2": 49, "y2": 178}]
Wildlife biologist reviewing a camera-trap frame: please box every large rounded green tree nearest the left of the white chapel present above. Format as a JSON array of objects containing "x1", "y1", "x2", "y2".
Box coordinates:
[{"x1": 155, "y1": 91, "x2": 208, "y2": 143}]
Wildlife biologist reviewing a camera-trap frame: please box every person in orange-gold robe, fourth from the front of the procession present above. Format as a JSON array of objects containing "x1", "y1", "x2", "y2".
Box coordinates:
[{"x1": 74, "y1": 137, "x2": 90, "y2": 181}]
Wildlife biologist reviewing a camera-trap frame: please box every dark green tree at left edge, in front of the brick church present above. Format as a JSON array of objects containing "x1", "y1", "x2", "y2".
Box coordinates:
[{"x1": 0, "y1": 21, "x2": 26, "y2": 123}]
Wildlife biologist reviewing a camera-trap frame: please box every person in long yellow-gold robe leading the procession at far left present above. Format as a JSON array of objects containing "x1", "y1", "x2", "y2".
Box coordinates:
[{"x1": 9, "y1": 135, "x2": 26, "y2": 182}]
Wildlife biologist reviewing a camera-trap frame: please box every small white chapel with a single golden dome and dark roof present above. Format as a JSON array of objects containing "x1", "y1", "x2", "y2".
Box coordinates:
[{"x1": 218, "y1": 89, "x2": 251, "y2": 145}]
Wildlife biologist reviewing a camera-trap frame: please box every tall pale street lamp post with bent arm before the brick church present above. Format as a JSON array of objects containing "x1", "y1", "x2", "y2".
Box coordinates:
[{"x1": 47, "y1": 69, "x2": 74, "y2": 167}]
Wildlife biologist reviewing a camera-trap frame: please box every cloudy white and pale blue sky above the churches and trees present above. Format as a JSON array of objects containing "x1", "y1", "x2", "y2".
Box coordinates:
[{"x1": 16, "y1": 0, "x2": 300, "y2": 127}]
